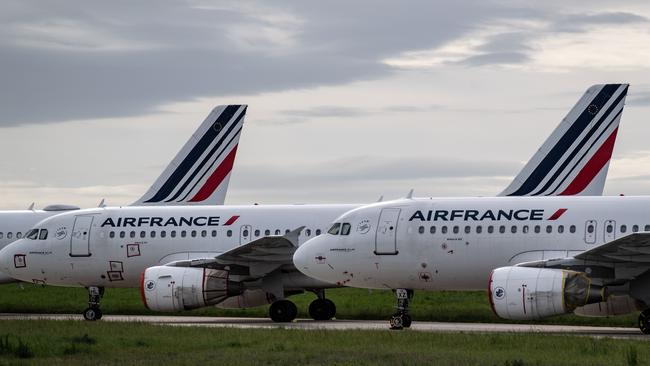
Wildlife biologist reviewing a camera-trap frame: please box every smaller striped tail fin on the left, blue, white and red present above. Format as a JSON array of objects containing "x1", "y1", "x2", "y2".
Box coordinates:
[{"x1": 131, "y1": 105, "x2": 247, "y2": 206}]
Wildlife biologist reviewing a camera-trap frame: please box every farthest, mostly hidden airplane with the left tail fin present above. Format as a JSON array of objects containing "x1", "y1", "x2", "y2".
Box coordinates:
[{"x1": 0, "y1": 105, "x2": 247, "y2": 284}]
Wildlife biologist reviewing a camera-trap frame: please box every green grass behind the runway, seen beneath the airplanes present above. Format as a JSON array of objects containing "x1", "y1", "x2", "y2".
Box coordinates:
[{"x1": 0, "y1": 284, "x2": 637, "y2": 327}]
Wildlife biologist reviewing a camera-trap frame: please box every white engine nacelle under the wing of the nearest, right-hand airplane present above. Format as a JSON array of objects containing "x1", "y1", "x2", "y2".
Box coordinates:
[{"x1": 488, "y1": 267, "x2": 605, "y2": 320}]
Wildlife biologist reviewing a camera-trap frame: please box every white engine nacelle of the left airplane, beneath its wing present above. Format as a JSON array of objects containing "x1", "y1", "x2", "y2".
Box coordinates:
[{"x1": 140, "y1": 266, "x2": 243, "y2": 311}]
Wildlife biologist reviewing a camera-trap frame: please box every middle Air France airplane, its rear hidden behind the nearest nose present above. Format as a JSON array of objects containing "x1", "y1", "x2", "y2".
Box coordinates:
[{"x1": 0, "y1": 85, "x2": 627, "y2": 322}]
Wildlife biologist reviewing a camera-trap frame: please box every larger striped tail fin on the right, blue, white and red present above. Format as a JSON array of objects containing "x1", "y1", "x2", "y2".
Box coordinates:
[{"x1": 499, "y1": 84, "x2": 629, "y2": 196}]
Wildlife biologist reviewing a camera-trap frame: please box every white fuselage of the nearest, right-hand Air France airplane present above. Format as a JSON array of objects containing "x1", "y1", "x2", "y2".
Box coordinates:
[{"x1": 294, "y1": 197, "x2": 650, "y2": 290}]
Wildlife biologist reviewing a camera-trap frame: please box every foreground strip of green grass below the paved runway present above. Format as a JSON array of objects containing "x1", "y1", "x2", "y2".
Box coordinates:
[{"x1": 0, "y1": 320, "x2": 650, "y2": 366}]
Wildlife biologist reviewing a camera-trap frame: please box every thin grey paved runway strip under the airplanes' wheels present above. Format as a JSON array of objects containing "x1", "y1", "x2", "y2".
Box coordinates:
[{"x1": 0, "y1": 314, "x2": 650, "y2": 340}]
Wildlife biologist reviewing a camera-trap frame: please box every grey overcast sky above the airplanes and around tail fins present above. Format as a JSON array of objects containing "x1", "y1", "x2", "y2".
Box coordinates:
[{"x1": 0, "y1": 0, "x2": 650, "y2": 209}]
